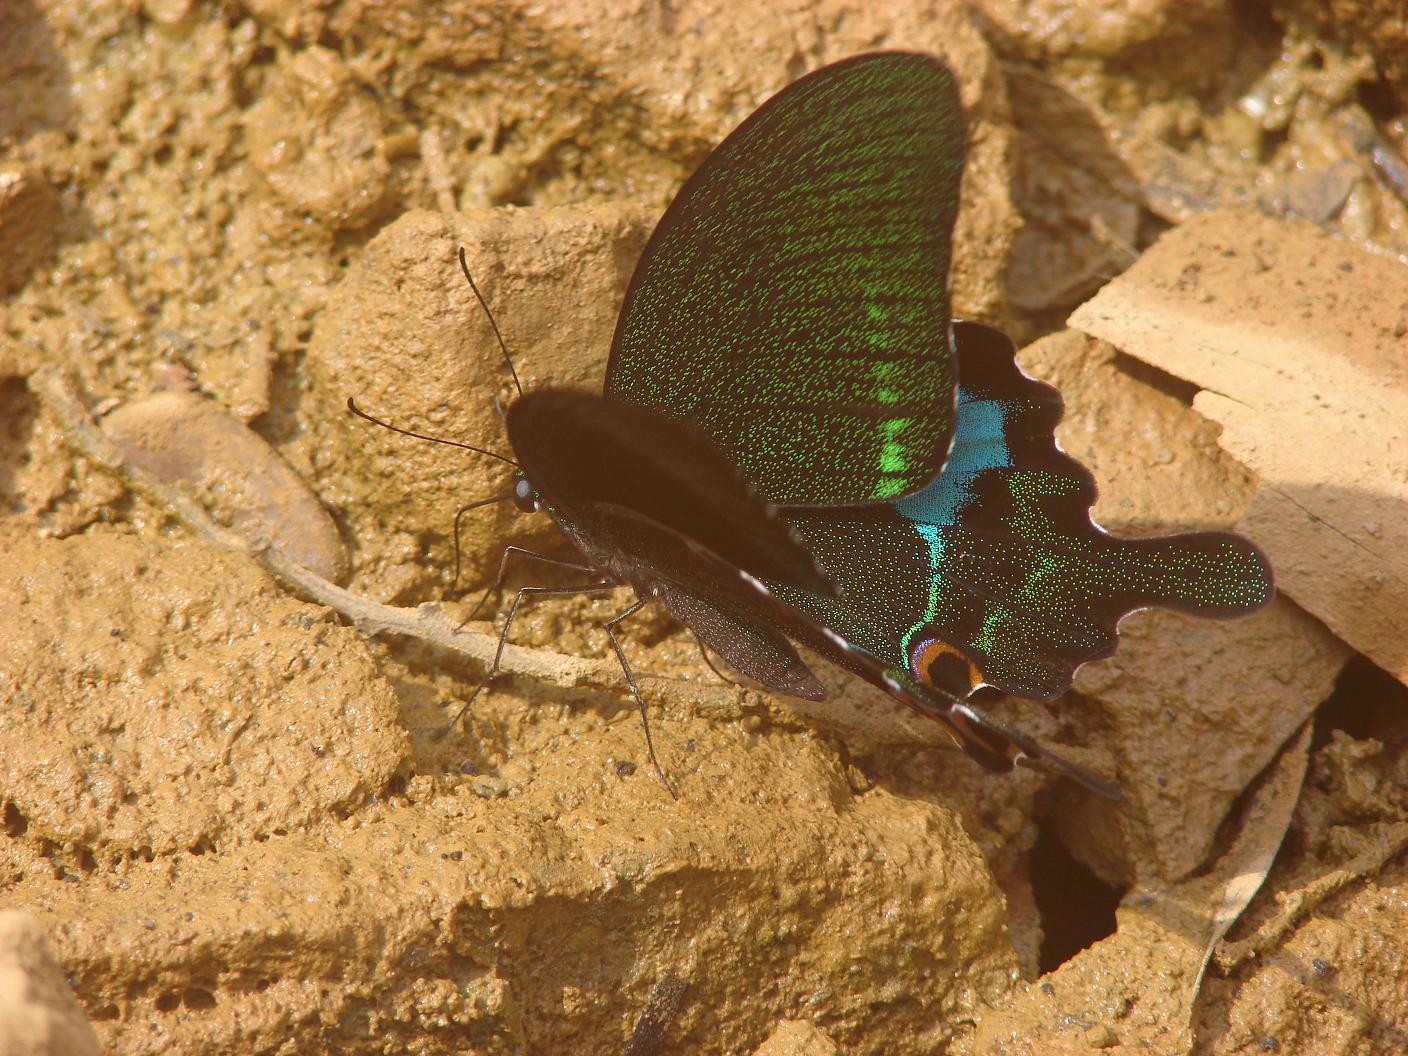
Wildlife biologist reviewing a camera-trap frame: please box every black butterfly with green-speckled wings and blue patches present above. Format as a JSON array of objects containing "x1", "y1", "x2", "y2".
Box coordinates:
[{"x1": 428, "y1": 52, "x2": 1273, "y2": 798}]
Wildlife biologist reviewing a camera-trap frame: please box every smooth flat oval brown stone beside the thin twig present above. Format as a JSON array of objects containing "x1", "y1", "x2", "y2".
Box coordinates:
[{"x1": 103, "y1": 390, "x2": 348, "y2": 583}]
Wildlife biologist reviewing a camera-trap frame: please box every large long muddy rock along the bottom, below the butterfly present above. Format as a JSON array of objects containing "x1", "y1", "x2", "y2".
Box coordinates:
[{"x1": 13, "y1": 720, "x2": 1015, "y2": 1056}]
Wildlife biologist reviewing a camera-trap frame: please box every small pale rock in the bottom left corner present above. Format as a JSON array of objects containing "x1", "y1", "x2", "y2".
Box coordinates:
[{"x1": 0, "y1": 910, "x2": 99, "y2": 1056}]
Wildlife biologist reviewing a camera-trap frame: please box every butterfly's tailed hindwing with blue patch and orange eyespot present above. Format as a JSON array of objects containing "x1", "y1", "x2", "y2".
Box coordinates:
[{"x1": 777, "y1": 324, "x2": 1273, "y2": 698}]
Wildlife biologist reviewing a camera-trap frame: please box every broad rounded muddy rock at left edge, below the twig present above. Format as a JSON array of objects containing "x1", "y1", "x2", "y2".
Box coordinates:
[{"x1": 0, "y1": 532, "x2": 407, "y2": 874}]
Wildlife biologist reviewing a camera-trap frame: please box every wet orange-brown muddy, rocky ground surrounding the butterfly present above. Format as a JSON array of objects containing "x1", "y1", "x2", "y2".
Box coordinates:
[{"x1": 0, "y1": 0, "x2": 1408, "y2": 1056}]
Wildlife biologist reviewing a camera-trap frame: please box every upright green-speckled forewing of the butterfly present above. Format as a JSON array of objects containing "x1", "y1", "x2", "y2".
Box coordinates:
[{"x1": 605, "y1": 52, "x2": 964, "y2": 505}]
